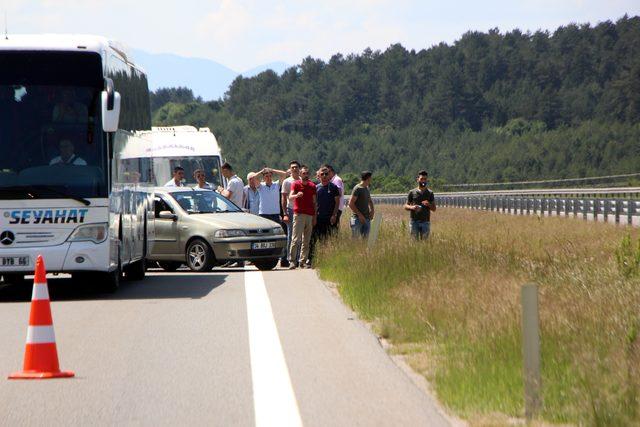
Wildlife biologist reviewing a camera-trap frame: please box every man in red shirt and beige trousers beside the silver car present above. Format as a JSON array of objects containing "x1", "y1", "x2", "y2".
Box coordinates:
[{"x1": 289, "y1": 165, "x2": 317, "y2": 270}]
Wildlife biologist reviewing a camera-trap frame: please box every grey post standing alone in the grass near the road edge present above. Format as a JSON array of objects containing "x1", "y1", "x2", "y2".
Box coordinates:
[{"x1": 522, "y1": 284, "x2": 542, "y2": 420}]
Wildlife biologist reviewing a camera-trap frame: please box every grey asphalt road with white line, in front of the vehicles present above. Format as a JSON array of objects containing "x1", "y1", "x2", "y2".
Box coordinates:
[{"x1": 0, "y1": 268, "x2": 449, "y2": 426}]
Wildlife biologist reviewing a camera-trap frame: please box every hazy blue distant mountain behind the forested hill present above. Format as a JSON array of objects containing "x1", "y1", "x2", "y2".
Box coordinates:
[{"x1": 132, "y1": 49, "x2": 289, "y2": 100}]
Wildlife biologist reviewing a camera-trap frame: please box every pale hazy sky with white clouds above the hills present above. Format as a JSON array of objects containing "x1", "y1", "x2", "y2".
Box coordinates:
[{"x1": 5, "y1": 0, "x2": 640, "y2": 71}]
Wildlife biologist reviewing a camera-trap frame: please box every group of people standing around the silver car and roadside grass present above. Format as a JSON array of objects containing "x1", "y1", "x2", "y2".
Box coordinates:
[{"x1": 166, "y1": 160, "x2": 436, "y2": 269}]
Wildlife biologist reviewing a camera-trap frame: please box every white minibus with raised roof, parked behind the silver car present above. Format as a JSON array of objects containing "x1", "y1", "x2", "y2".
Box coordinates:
[{"x1": 134, "y1": 126, "x2": 225, "y2": 189}]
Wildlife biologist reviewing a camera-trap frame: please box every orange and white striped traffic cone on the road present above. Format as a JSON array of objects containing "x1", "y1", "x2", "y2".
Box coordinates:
[{"x1": 9, "y1": 255, "x2": 75, "y2": 379}]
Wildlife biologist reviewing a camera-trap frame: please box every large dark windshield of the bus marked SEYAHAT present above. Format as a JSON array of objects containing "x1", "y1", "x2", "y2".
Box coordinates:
[{"x1": 0, "y1": 51, "x2": 108, "y2": 199}]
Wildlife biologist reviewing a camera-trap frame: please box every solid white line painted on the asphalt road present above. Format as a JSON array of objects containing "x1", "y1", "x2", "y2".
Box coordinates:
[{"x1": 244, "y1": 271, "x2": 302, "y2": 426}]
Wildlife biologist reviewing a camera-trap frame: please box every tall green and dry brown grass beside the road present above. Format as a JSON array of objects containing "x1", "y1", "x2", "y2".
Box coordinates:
[{"x1": 317, "y1": 206, "x2": 640, "y2": 425}]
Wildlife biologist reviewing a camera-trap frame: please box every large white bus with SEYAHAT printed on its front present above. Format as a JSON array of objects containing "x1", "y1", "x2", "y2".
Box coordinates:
[{"x1": 0, "y1": 34, "x2": 154, "y2": 291}]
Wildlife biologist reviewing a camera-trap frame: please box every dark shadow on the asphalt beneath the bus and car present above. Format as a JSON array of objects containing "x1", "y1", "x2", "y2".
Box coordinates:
[{"x1": 0, "y1": 270, "x2": 228, "y2": 302}]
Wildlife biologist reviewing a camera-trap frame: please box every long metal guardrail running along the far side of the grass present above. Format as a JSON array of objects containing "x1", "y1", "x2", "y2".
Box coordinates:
[{"x1": 364, "y1": 187, "x2": 640, "y2": 227}]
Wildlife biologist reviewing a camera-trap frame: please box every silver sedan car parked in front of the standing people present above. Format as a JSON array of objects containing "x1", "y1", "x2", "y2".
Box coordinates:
[{"x1": 148, "y1": 187, "x2": 287, "y2": 271}]
